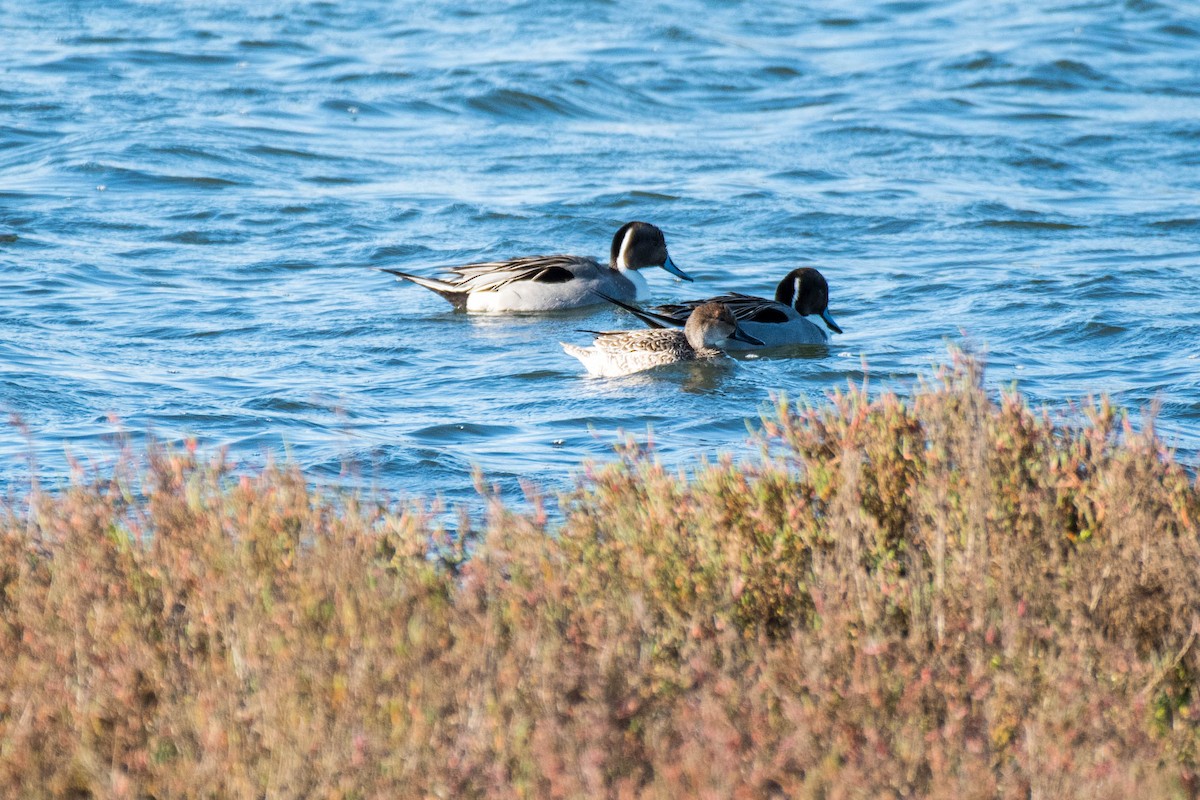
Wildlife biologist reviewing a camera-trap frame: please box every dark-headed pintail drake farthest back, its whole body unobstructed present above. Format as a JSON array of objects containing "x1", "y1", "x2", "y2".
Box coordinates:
[{"x1": 374, "y1": 222, "x2": 691, "y2": 316}]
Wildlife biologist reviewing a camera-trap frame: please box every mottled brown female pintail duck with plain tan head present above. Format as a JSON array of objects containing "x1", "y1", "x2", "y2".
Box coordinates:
[{"x1": 560, "y1": 302, "x2": 762, "y2": 378}]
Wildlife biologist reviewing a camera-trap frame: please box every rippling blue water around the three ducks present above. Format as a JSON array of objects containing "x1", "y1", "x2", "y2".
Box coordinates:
[{"x1": 0, "y1": 0, "x2": 1200, "y2": 503}]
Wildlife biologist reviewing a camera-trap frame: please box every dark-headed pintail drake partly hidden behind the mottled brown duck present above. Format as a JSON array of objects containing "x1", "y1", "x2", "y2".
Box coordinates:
[{"x1": 607, "y1": 266, "x2": 841, "y2": 350}]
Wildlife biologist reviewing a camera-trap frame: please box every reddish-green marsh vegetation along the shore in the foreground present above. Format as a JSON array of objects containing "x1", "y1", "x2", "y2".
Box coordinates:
[{"x1": 0, "y1": 363, "x2": 1200, "y2": 799}]
